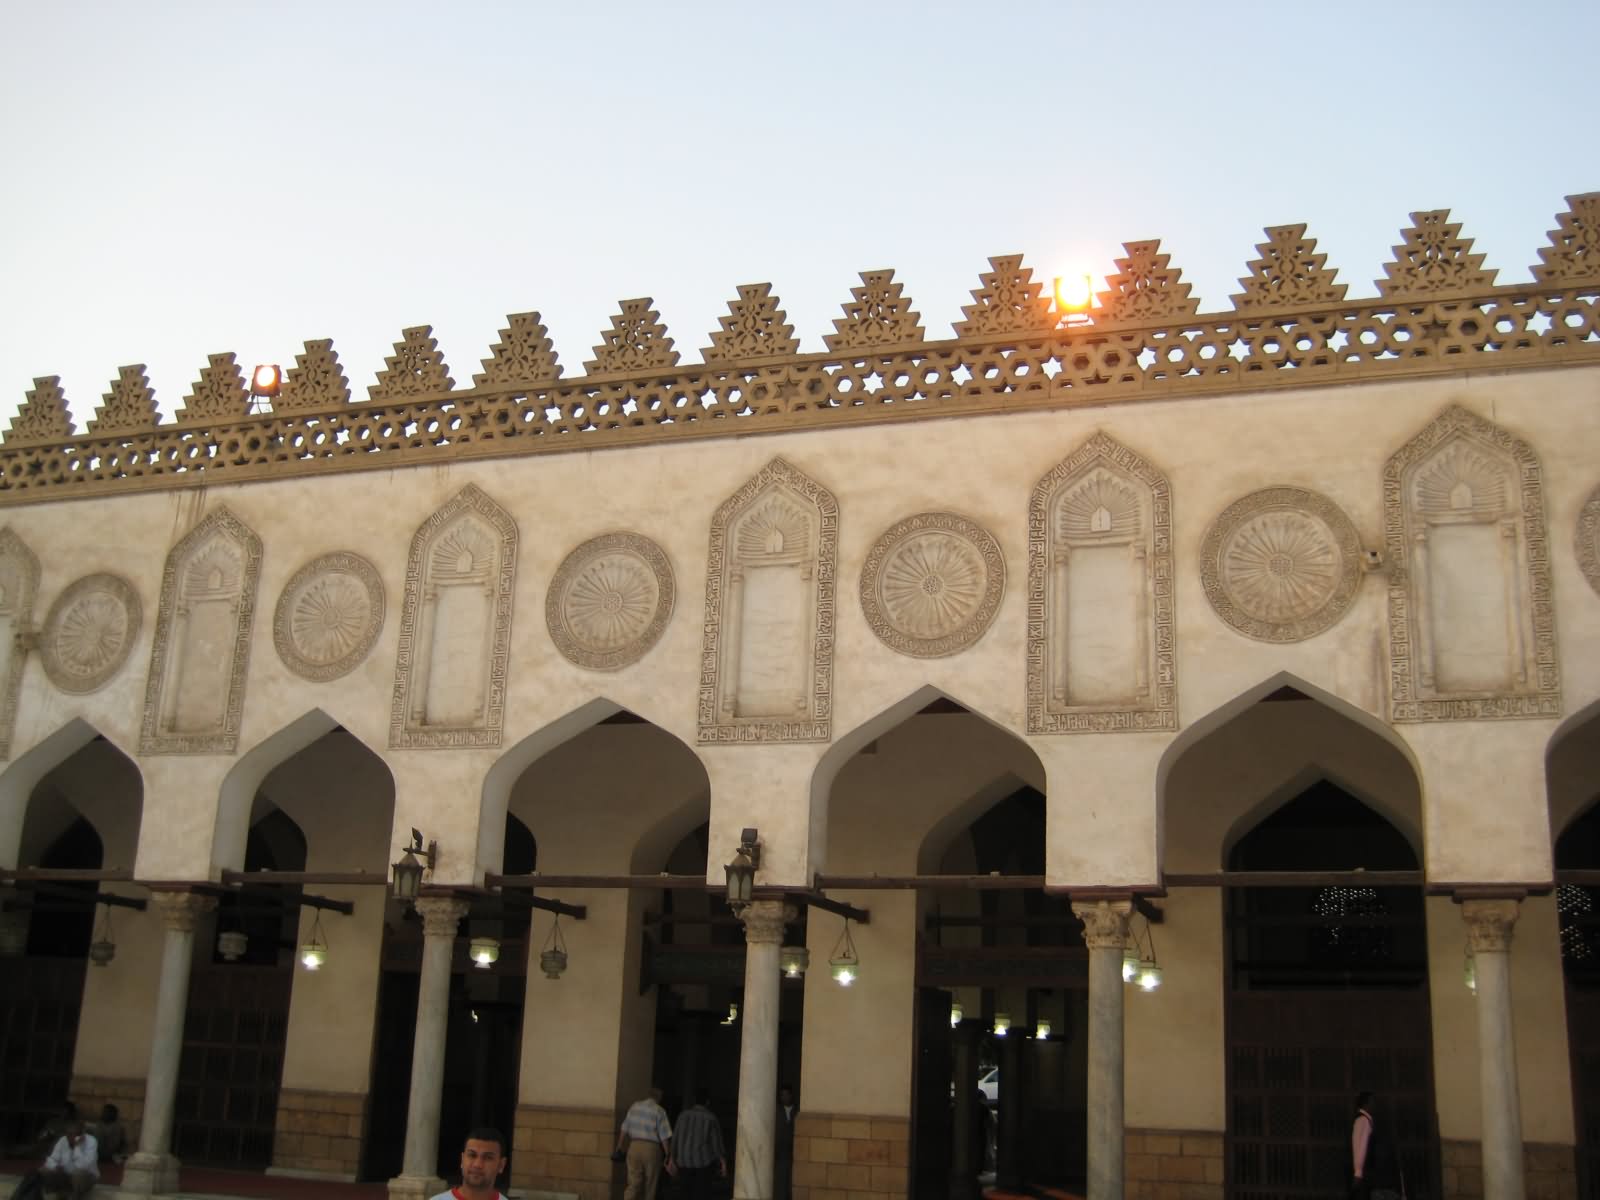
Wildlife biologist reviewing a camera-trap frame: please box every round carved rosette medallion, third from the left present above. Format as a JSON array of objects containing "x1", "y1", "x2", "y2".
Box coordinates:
[{"x1": 544, "y1": 533, "x2": 674, "y2": 670}]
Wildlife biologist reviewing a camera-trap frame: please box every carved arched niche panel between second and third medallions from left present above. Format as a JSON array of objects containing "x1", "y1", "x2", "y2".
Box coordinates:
[{"x1": 389, "y1": 483, "x2": 517, "y2": 749}]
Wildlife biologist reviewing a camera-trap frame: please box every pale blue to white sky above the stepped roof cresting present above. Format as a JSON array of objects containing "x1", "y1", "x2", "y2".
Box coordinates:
[{"x1": 0, "y1": 0, "x2": 1600, "y2": 429}]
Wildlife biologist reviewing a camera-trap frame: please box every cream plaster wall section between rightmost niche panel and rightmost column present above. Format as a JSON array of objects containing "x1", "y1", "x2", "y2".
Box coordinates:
[{"x1": 1405, "y1": 720, "x2": 1555, "y2": 883}]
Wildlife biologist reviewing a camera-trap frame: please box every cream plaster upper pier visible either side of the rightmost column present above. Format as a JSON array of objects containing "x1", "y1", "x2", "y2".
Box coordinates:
[{"x1": 1427, "y1": 896, "x2": 1574, "y2": 1146}]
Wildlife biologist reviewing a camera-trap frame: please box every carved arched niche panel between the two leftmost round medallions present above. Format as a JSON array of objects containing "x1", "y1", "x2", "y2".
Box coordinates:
[{"x1": 139, "y1": 509, "x2": 261, "y2": 754}]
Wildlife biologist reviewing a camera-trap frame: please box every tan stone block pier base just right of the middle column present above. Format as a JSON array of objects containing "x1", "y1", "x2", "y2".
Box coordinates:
[{"x1": 794, "y1": 1112, "x2": 910, "y2": 1200}]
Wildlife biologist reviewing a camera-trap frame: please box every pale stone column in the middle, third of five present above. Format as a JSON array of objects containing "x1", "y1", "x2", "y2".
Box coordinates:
[{"x1": 733, "y1": 901, "x2": 798, "y2": 1200}]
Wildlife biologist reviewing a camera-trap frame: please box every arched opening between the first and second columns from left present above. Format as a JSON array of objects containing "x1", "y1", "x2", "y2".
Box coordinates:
[{"x1": 206, "y1": 720, "x2": 394, "y2": 1178}]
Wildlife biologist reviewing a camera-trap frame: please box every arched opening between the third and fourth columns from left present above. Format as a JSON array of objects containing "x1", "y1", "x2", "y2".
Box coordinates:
[{"x1": 812, "y1": 688, "x2": 1049, "y2": 1200}]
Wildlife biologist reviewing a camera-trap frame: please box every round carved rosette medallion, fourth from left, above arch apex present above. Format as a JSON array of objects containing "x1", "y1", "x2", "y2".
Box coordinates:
[{"x1": 861, "y1": 512, "x2": 1005, "y2": 658}]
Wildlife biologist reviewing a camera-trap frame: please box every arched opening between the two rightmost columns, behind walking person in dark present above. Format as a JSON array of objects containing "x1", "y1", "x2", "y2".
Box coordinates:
[{"x1": 1163, "y1": 678, "x2": 1440, "y2": 1197}]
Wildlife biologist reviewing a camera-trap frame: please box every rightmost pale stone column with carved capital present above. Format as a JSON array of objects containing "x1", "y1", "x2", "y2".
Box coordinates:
[{"x1": 1461, "y1": 899, "x2": 1523, "y2": 1200}]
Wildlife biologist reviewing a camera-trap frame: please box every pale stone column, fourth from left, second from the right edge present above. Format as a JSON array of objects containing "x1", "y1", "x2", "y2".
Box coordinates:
[{"x1": 1072, "y1": 901, "x2": 1133, "y2": 1200}]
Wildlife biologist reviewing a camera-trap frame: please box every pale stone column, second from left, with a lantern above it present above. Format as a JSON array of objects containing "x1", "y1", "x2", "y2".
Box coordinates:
[{"x1": 389, "y1": 896, "x2": 467, "y2": 1200}]
